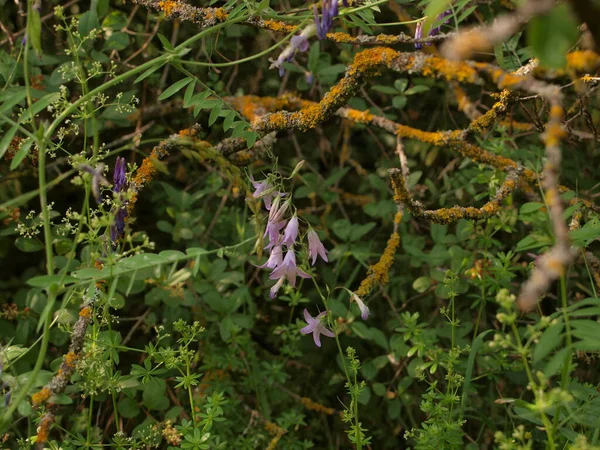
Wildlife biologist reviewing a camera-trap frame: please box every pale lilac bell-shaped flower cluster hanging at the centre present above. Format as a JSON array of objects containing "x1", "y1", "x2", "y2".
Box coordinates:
[{"x1": 252, "y1": 180, "x2": 327, "y2": 298}]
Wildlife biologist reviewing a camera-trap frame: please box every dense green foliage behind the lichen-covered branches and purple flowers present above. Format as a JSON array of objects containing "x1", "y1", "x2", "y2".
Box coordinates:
[{"x1": 0, "y1": 0, "x2": 600, "y2": 450}]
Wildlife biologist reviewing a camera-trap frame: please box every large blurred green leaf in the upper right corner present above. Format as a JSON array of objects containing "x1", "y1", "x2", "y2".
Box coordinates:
[{"x1": 527, "y1": 3, "x2": 579, "y2": 69}]
